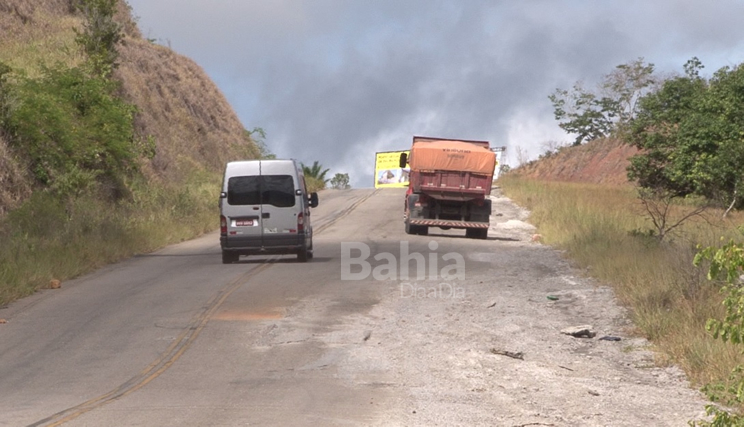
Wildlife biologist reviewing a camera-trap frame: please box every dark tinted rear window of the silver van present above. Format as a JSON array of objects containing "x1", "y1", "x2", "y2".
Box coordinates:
[{"x1": 227, "y1": 175, "x2": 295, "y2": 208}]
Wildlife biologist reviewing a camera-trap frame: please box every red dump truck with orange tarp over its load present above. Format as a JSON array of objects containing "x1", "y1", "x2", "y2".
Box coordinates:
[{"x1": 400, "y1": 136, "x2": 496, "y2": 239}]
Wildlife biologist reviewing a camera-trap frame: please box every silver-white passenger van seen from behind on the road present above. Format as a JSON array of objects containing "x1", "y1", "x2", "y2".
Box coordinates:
[{"x1": 220, "y1": 160, "x2": 318, "y2": 264}]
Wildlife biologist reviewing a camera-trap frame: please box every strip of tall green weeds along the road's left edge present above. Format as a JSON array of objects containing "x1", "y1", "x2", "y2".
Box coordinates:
[{"x1": 0, "y1": 174, "x2": 219, "y2": 306}]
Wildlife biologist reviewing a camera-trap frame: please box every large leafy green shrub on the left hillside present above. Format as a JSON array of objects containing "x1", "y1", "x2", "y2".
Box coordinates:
[{"x1": 0, "y1": 66, "x2": 138, "y2": 198}]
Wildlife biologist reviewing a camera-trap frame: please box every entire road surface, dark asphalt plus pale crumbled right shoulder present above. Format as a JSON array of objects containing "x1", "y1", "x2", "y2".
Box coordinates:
[{"x1": 0, "y1": 189, "x2": 702, "y2": 426}]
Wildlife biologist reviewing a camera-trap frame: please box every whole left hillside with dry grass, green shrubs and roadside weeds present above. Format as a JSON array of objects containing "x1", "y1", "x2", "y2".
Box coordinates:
[{"x1": 0, "y1": 0, "x2": 259, "y2": 305}]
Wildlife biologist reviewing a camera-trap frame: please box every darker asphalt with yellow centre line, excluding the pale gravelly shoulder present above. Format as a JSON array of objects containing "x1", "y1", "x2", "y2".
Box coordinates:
[{"x1": 0, "y1": 190, "x2": 390, "y2": 426}]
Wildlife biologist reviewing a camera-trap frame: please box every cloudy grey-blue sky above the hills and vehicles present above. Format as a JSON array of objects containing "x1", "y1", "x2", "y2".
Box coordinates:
[{"x1": 128, "y1": 0, "x2": 744, "y2": 188}]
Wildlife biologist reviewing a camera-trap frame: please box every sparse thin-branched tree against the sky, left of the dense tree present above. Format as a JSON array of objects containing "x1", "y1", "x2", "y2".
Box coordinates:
[{"x1": 548, "y1": 58, "x2": 657, "y2": 145}]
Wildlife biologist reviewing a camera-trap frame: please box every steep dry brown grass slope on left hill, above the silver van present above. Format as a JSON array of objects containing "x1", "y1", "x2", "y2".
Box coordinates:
[{"x1": 116, "y1": 38, "x2": 259, "y2": 181}]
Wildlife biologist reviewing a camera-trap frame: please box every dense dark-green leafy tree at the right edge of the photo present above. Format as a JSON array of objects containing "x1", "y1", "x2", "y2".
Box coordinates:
[{"x1": 628, "y1": 58, "x2": 744, "y2": 214}]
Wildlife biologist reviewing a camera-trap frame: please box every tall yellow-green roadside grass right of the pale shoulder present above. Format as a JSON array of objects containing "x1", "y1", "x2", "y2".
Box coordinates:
[{"x1": 499, "y1": 175, "x2": 744, "y2": 394}]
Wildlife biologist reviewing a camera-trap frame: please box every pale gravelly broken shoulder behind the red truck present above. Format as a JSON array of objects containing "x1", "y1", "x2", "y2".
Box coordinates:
[{"x1": 328, "y1": 191, "x2": 706, "y2": 426}]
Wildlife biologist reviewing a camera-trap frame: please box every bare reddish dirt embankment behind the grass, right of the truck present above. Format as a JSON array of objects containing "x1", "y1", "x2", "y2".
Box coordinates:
[{"x1": 514, "y1": 138, "x2": 638, "y2": 185}]
